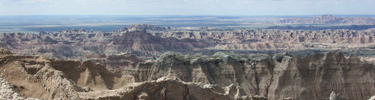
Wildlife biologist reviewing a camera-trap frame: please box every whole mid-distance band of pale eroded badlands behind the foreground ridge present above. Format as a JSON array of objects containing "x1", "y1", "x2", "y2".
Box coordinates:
[{"x1": 0, "y1": 25, "x2": 375, "y2": 61}]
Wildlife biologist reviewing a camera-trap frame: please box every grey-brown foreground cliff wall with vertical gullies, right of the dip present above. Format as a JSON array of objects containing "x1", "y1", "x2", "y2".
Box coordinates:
[{"x1": 128, "y1": 52, "x2": 375, "y2": 100}]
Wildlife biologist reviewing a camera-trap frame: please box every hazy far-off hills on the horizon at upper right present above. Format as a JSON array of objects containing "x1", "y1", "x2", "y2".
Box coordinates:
[{"x1": 276, "y1": 15, "x2": 375, "y2": 25}]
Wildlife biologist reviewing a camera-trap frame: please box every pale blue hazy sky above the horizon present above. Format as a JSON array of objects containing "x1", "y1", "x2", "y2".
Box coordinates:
[{"x1": 0, "y1": 0, "x2": 375, "y2": 16}]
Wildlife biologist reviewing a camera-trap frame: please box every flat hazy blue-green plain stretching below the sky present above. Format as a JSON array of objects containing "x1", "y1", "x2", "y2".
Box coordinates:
[{"x1": 0, "y1": 15, "x2": 375, "y2": 33}]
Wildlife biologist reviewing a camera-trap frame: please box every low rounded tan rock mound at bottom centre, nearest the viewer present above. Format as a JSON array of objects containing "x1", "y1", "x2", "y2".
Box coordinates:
[{"x1": 79, "y1": 78, "x2": 267, "y2": 100}]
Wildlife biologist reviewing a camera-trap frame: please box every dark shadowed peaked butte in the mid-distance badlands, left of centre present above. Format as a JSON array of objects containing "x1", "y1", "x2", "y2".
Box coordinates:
[{"x1": 113, "y1": 31, "x2": 205, "y2": 52}]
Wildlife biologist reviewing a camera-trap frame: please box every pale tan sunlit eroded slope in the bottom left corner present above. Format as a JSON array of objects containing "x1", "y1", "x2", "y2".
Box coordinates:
[{"x1": 0, "y1": 56, "x2": 83, "y2": 99}]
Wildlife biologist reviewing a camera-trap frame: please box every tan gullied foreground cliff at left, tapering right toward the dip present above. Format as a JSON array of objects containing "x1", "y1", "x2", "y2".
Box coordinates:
[{"x1": 0, "y1": 52, "x2": 134, "y2": 99}]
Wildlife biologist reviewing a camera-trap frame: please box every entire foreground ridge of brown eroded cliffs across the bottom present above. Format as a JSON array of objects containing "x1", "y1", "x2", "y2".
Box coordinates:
[{"x1": 0, "y1": 49, "x2": 375, "y2": 100}]
